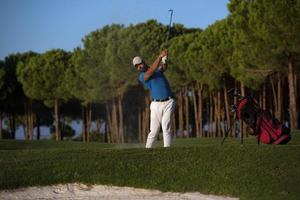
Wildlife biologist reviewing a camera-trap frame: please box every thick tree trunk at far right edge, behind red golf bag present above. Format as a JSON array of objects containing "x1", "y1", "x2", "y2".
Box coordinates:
[{"x1": 288, "y1": 56, "x2": 298, "y2": 130}]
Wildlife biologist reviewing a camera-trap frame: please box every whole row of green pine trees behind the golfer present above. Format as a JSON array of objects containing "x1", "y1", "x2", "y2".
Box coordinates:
[{"x1": 0, "y1": 0, "x2": 300, "y2": 143}]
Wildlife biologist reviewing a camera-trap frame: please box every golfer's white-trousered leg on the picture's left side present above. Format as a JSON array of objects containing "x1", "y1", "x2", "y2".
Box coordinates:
[{"x1": 146, "y1": 102, "x2": 161, "y2": 148}]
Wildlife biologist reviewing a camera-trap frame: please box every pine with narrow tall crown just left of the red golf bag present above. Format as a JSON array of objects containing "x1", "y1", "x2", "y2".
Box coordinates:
[{"x1": 193, "y1": 19, "x2": 233, "y2": 136}]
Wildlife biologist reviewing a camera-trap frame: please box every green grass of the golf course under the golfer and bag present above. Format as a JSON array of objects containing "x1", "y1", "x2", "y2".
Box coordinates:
[{"x1": 0, "y1": 131, "x2": 300, "y2": 200}]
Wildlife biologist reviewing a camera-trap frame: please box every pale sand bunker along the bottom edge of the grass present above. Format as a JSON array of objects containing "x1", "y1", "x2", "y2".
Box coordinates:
[{"x1": 0, "y1": 183, "x2": 237, "y2": 200}]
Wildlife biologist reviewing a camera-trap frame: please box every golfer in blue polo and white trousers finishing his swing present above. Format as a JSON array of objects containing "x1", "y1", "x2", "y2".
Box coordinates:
[{"x1": 132, "y1": 50, "x2": 175, "y2": 148}]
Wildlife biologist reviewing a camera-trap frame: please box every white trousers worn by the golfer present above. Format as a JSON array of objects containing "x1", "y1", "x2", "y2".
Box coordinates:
[{"x1": 146, "y1": 99, "x2": 175, "y2": 148}]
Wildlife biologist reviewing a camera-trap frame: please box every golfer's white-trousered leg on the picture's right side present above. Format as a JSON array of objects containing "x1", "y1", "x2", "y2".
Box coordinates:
[{"x1": 161, "y1": 99, "x2": 175, "y2": 147}]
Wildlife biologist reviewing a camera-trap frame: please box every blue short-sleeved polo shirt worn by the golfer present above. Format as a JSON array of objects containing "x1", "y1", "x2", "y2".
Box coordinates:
[{"x1": 139, "y1": 70, "x2": 172, "y2": 99}]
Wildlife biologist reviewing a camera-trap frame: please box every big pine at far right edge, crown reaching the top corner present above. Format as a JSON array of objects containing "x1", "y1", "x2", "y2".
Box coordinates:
[{"x1": 249, "y1": 0, "x2": 300, "y2": 129}]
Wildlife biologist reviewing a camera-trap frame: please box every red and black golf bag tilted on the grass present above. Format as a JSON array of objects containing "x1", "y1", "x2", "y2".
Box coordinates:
[{"x1": 234, "y1": 96, "x2": 291, "y2": 144}]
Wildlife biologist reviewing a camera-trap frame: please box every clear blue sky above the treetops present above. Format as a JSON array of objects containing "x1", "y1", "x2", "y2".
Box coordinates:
[{"x1": 0, "y1": 0, "x2": 229, "y2": 60}]
